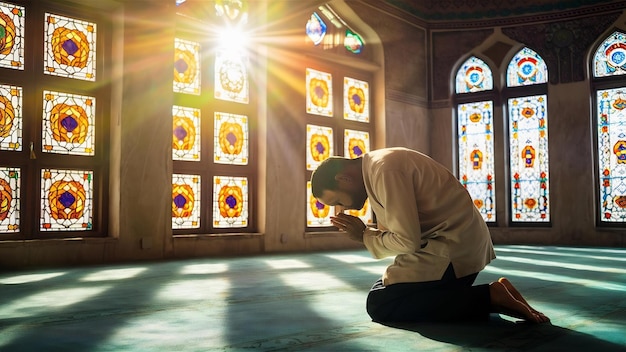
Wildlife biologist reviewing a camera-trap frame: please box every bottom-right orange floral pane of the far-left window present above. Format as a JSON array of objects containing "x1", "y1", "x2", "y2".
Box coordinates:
[{"x1": 41, "y1": 169, "x2": 93, "y2": 231}]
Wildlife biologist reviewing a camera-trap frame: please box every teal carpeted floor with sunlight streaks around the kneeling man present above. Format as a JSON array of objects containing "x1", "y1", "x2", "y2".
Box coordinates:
[{"x1": 0, "y1": 246, "x2": 626, "y2": 352}]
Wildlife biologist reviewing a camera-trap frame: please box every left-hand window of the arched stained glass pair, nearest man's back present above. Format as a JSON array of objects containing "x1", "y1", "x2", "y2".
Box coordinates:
[{"x1": 455, "y1": 56, "x2": 496, "y2": 223}]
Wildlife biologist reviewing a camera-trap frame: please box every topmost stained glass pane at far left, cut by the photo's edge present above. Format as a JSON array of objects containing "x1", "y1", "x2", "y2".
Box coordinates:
[{"x1": 0, "y1": 2, "x2": 25, "y2": 70}]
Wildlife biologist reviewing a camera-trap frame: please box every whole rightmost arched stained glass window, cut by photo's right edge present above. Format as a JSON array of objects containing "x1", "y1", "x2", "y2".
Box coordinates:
[{"x1": 590, "y1": 30, "x2": 626, "y2": 226}]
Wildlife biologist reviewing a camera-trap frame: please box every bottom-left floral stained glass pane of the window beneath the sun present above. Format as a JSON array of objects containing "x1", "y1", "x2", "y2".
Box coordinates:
[{"x1": 172, "y1": 174, "x2": 201, "y2": 229}]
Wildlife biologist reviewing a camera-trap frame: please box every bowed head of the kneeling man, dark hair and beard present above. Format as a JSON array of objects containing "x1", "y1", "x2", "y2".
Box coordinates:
[{"x1": 311, "y1": 156, "x2": 367, "y2": 210}]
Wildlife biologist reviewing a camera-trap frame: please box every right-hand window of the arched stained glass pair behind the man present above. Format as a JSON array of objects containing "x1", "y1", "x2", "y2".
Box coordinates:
[{"x1": 506, "y1": 47, "x2": 550, "y2": 222}]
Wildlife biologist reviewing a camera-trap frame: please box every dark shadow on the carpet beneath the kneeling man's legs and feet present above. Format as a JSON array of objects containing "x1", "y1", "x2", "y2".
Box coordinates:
[{"x1": 383, "y1": 315, "x2": 626, "y2": 352}]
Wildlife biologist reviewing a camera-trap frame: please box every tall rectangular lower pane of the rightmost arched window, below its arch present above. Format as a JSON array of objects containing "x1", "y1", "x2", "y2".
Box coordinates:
[{"x1": 597, "y1": 88, "x2": 626, "y2": 222}]
